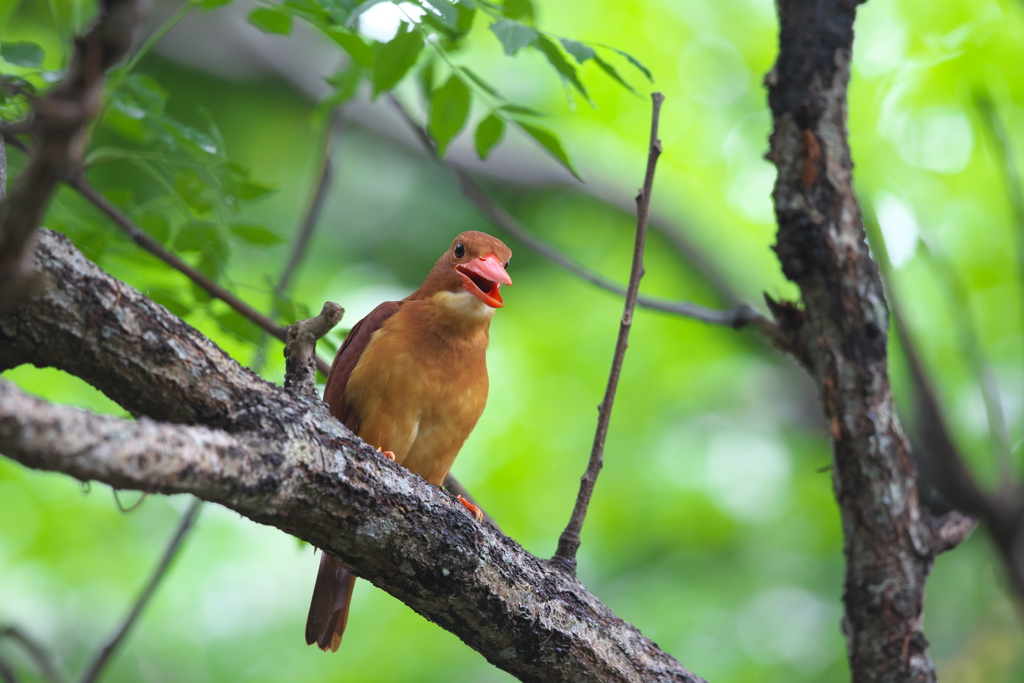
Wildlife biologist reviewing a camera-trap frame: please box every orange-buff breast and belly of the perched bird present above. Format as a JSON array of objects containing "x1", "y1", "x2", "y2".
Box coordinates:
[{"x1": 345, "y1": 302, "x2": 487, "y2": 485}]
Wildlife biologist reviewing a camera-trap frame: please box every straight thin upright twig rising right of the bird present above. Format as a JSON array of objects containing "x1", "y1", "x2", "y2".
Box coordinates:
[{"x1": 552, "y1": 92, "x2": 665, "y2": 573}]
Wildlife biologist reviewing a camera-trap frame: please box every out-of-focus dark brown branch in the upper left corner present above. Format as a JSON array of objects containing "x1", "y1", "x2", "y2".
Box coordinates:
[{"x1": 0, "y1": 0, "x2": 140, "y2": 302}]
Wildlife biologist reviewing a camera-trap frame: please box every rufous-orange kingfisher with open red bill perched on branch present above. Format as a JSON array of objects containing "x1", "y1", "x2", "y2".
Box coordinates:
[{"x1": 306, "y1": 230, "x2": 512, "y2": 652}]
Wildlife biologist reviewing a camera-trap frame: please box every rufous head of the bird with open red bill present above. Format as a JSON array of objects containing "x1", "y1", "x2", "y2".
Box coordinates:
[{"x1": 410, "y1": 230, "x2": 512, "y2": 308}]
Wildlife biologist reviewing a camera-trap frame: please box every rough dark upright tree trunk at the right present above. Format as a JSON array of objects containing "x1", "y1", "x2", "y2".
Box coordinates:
[{"x1": 767, "y1": 0, "x2": 950, "y2": 681}]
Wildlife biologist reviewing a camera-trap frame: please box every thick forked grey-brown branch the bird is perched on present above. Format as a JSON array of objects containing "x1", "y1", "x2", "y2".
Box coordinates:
[{"x1": 0, "y1": 230, "x2": 701, "y2": 682}]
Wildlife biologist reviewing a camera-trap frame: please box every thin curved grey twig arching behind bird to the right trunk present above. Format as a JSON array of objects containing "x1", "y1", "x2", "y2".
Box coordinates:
[{"x1": 387, "y1": 94, "x2": 766, "y2": 329}]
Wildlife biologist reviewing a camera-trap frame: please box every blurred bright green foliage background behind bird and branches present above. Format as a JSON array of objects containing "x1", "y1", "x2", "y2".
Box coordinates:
[{"x1": 0, "y1": 0, "x2": 1024, "y2": 683}]
